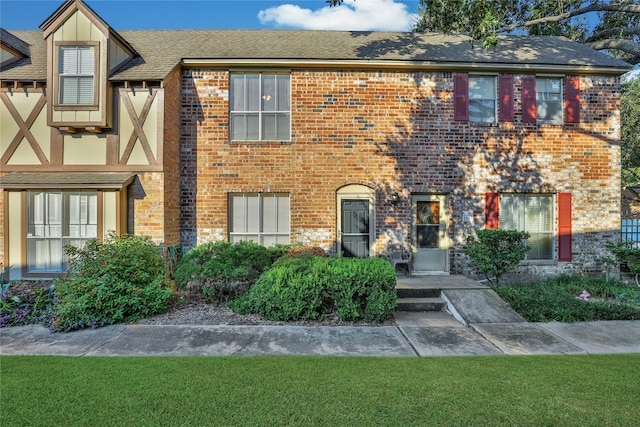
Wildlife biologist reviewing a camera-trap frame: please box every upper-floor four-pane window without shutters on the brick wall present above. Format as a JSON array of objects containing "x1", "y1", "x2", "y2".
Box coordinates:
[{"x1": 229, "y1": 73, "x2": 291, "y2": 141}]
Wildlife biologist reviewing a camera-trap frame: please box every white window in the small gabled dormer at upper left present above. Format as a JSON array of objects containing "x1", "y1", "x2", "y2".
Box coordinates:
[{"x1": 58, "y1": 45, "x2": 96, "y2": 105}]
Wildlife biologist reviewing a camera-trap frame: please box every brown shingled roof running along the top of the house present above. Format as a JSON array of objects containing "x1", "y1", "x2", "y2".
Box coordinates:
[{"x1": 0, "y1": 30, "x2": 631, "y2": 81}]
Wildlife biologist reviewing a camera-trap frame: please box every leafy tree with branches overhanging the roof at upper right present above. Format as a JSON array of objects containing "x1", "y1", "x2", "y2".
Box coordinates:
[{"x1": 327, "y1": 0, "x2": 640, "y2": 64}]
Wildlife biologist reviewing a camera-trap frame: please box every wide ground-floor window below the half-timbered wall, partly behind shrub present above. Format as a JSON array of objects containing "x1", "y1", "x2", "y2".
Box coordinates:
[{"x1": 27, "y1": 190, "x2": 98, "y2": 273}]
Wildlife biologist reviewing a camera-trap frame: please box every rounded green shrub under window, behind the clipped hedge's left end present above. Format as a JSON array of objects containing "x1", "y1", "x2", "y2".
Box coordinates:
[{"x1": 175, "y1": 241, "x2": 289, "y2": 302}]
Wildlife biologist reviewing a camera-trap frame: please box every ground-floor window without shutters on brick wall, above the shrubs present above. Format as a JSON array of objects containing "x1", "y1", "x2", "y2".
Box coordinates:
[{"x1": 229, "y1": 193, "x2": 290, "y2": 246}]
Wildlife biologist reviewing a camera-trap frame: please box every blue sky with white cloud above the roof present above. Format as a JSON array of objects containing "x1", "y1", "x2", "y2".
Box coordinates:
[{"x1": 0, "y1": 0, "x2": 418, "y2": 31}]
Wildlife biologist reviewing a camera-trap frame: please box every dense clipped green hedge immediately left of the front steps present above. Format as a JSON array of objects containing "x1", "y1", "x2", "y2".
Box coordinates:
[{"x1": 228, "y1": 255, "x2": 397, "y2": 322}]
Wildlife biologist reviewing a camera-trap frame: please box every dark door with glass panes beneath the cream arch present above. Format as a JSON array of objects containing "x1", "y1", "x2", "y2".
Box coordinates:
[{"x1": 341, "y1": 199, "x2": 369, "y2": 258}]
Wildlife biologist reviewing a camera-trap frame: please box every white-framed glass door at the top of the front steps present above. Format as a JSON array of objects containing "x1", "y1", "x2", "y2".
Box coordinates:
[{"x1": 411, "y1": 194, "x2": 449, "y2": 274}]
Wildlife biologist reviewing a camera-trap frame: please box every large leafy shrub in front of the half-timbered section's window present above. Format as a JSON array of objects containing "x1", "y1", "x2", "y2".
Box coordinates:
[{"x1": 50, "y1": 234, "x2": 172, "y2": 331}]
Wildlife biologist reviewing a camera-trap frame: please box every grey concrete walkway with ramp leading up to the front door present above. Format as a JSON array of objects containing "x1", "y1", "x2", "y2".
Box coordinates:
[{"x1": 0, "y1": 276, "x2": 640, "y2": 357}]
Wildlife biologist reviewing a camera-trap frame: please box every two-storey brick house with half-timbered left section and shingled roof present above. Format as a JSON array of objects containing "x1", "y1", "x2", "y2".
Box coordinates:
[{"x1": 0, "y1": 0, "x2": 630, "y2": 279}]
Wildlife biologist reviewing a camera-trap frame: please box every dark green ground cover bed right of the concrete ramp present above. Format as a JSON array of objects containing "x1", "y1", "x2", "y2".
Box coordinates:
[{"x1": 493, "y1": 276, "x2": 640, "y2": 322}]
